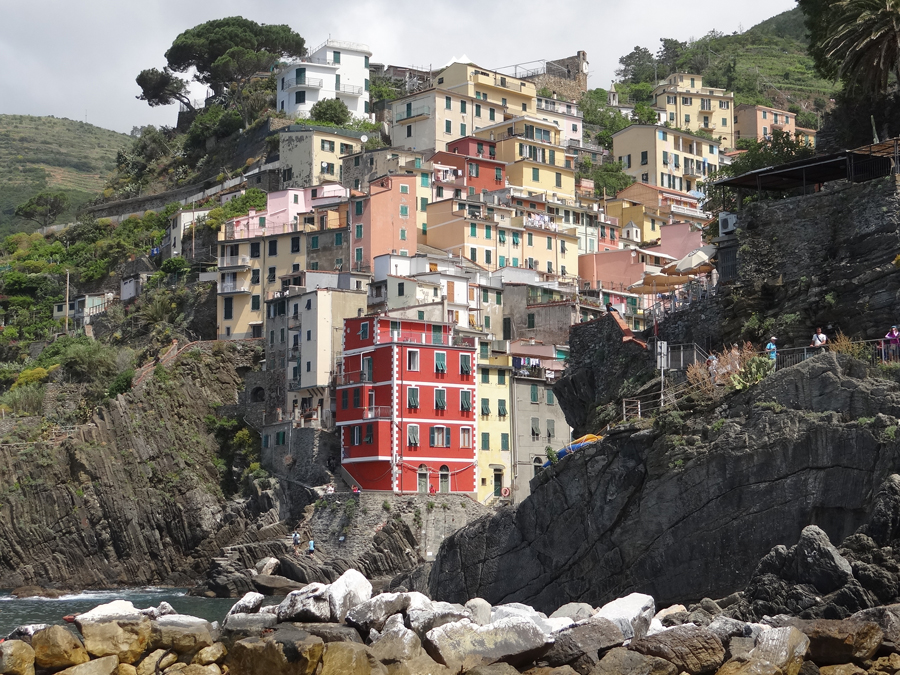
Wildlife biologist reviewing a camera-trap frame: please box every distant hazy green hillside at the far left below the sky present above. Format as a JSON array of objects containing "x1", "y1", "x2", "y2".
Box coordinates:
[{"x1": 0, "y1": 115, "x2": 132, "y2": 236}]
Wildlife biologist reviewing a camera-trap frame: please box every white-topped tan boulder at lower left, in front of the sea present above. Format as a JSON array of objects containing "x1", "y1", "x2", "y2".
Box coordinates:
[{"x1": 75, "y1": 600, "x2": 151, "y2": 666}]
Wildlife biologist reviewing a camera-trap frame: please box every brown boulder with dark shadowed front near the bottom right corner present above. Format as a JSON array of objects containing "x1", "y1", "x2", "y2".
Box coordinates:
[{"x1": 797, "y1": 619, "x2": 884, "y2": 666}]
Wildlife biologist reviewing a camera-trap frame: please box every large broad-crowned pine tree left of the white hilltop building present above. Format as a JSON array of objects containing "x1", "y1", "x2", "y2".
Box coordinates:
[{"x1": 160, "y1": 16, "x2": 306, "y2": 94}]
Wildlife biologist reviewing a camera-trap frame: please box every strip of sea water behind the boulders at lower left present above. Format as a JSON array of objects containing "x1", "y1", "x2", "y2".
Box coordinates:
[{"x1": 0, "y1": 587, "x2": 282, "y2": 638}]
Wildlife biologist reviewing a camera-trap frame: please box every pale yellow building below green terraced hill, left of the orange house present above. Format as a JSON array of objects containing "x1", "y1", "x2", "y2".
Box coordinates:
[{"x1": 653, "y1": 73, "x2": 734, "y2": 148}]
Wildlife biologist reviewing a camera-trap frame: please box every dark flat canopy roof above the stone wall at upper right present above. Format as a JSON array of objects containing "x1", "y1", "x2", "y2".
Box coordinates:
[{"x1": 713, "y1": 138, "x2": 900, "y2": 190}]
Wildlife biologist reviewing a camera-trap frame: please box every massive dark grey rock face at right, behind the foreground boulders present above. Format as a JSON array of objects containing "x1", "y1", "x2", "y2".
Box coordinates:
[{"x1": 429, "y1": 353, "x2": 900, "y2": 618}]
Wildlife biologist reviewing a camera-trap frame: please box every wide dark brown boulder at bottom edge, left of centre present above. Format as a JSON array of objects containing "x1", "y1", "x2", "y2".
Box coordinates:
[{"x1": 227, "y1": 626, "x2": 325, "y2": 675}]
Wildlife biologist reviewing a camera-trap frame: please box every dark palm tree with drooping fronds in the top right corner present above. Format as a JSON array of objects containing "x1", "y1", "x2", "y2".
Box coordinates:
[{"x1": 799, "y1": 0, "x2": 900, "y2": 93}]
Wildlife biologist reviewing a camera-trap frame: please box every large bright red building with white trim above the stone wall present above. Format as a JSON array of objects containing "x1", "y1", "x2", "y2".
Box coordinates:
[{"x1": 336, "y1": 315, "x2": 478, "y2": 493}]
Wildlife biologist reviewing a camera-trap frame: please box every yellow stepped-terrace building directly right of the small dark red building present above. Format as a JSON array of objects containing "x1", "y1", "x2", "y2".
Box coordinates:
[{"x1": 474, "y1": 117, "x2": 575, "y2": 199}]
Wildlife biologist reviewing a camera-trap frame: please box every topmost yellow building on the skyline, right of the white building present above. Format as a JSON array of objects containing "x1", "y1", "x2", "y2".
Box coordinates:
[{"x1": 435, "y1": 63, "x2": 537, "y2": 116}]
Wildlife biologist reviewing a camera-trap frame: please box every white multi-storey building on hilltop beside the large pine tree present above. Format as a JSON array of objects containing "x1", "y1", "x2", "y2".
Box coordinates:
[{"x1": 277, "y1": 40, "x2": 372, "y2": 119}]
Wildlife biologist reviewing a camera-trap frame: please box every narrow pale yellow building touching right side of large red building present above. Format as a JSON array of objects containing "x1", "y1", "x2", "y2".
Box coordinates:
[{"x1": 476, "y1": 348, "x2": 514, "y2": 503}]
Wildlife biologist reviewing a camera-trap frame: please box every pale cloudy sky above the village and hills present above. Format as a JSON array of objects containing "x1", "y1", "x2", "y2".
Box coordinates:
[{"x1": 0, "y1": 0, "x2": 796, "y2": 133}]
